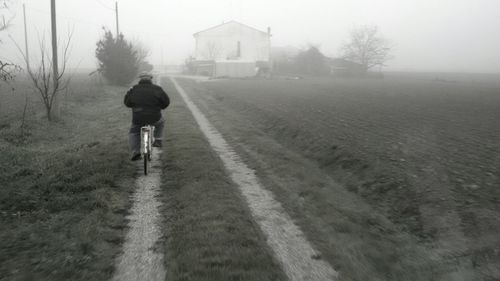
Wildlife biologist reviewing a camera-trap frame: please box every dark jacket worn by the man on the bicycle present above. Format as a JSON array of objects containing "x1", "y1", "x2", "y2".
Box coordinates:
[{"x1": 123, "y1": 80, "x2": 170, "y2": 126}]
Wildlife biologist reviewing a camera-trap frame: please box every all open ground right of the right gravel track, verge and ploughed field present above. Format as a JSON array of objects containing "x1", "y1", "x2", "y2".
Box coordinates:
[{"x1": 179, "y1": 75, "x2": 500, "y2": 280}]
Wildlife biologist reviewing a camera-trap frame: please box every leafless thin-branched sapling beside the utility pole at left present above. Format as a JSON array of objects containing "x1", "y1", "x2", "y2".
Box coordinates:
[{"x1": 14, "y1": 32, "x2": 73, "y2": 121}]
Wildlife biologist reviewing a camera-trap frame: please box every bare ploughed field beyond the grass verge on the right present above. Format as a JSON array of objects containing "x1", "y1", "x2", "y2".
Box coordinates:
[{"x1": 178, "y1": 75, "x2": 500, "y2": 280}]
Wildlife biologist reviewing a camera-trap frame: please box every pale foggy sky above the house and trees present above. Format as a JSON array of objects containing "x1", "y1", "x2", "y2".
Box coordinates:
[{"x1": 0, "y1": 0, "x2": 500, "y2": 73}]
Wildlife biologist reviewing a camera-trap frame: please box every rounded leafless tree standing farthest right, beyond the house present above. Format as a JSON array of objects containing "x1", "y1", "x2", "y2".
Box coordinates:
[{"x1": 342, "y1": 25, "x2": 392, "y2": 71}]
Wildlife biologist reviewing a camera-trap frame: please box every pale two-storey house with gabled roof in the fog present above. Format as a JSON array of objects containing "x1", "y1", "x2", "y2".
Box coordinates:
[{"x1": 193, "y1": 21, "x2": 271, "y2": 77}]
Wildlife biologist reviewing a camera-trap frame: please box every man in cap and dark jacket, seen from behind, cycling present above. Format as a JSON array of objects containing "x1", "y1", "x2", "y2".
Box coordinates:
[{"x1": 123, "y1": 73, "x2": 170, "y2": 161}]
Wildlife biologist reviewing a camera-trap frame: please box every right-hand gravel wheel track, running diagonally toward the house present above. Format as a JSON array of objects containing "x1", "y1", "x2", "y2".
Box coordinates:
[{"x1": 172, "y1": 78, "x2": 338, "y2": 280}]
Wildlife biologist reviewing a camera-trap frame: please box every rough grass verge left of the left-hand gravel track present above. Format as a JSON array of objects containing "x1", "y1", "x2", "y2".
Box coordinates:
[{"x1": 0, "y1": 76, "x2": 135, "y2": 280}]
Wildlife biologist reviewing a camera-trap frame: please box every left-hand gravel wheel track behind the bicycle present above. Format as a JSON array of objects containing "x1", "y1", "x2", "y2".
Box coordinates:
[{"x1": 113, "y1": 150, "x2": 166, "y2": 281}]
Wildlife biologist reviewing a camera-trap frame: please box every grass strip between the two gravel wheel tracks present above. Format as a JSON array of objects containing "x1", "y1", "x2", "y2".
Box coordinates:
[{"x1": 158, "y1": 79, "x2": 286, "y2": 281}]
